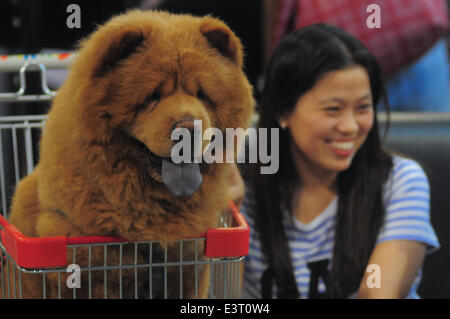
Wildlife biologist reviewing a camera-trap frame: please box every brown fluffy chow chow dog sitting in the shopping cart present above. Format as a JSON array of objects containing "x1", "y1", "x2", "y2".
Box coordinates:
[{"x1": 10, "y1": 11, "x2": 254, "y2": 298}]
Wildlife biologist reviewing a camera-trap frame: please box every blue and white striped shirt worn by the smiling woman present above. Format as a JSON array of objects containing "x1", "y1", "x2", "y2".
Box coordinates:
[{"x1": 241, "y1": 156, "x2": 439, "y2": 298}]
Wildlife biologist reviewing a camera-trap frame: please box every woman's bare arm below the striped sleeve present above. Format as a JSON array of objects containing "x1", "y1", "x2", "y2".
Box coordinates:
[{"x1": 357, "y1": 240, "x2": 426, "y2": 298}]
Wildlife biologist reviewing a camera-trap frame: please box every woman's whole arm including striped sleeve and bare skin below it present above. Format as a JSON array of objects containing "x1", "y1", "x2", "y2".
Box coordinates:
[{"x1": 357, "y1": 158, "x2": 439, "y2": 298}]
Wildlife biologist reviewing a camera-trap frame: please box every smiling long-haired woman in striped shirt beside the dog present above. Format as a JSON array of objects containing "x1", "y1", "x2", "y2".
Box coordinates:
[{"x1": 241, "y1": 24, "x2": 439, "y2": 298}]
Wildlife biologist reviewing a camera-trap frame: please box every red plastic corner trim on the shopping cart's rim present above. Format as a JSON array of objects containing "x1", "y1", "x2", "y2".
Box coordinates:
[{"x1": 0, "y1": 201, "x2": 250, "y2": 269}]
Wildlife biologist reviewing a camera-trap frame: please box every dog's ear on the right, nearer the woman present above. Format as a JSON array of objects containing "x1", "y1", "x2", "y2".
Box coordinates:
[{"x1": 200, "y1": 17, "x2": 243, "y2": 67}]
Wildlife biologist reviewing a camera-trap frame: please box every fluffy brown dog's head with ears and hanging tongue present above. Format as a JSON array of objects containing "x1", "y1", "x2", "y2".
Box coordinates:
[{"x1": 72, "y1": 11, "x2": 254, "y2": 195}]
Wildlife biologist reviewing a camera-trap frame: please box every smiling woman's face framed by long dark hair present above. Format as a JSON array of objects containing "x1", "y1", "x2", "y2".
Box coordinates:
[{"x1": 282, "y1": 66, "x2": 374, "y2": 178}]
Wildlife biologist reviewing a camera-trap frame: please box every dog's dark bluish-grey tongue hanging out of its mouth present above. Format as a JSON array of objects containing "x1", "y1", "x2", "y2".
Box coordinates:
[{"x1": 162, "y1": 159, "x2": 203, "y2": 196}]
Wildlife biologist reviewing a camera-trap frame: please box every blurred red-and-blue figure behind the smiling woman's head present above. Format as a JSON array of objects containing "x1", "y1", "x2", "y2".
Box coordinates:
[{"x1": 265, "y1": 0, "x2": 450, "y2": 112}]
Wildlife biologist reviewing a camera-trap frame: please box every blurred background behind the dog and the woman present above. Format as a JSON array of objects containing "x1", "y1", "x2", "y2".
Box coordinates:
[{"x1": 0, "y1": 0, "x2": 450, "y2": 298}]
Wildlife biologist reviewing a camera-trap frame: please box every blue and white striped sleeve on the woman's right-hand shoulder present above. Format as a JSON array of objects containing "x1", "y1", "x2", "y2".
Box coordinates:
[{"x1": 377, "y1": 157, "x2": 439, "y2": 253}]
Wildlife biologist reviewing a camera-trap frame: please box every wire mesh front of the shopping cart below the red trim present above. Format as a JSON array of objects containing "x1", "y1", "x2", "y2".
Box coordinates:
[{"x1": 0, "y1": 219, "x2": 243, "y2": 299}]
